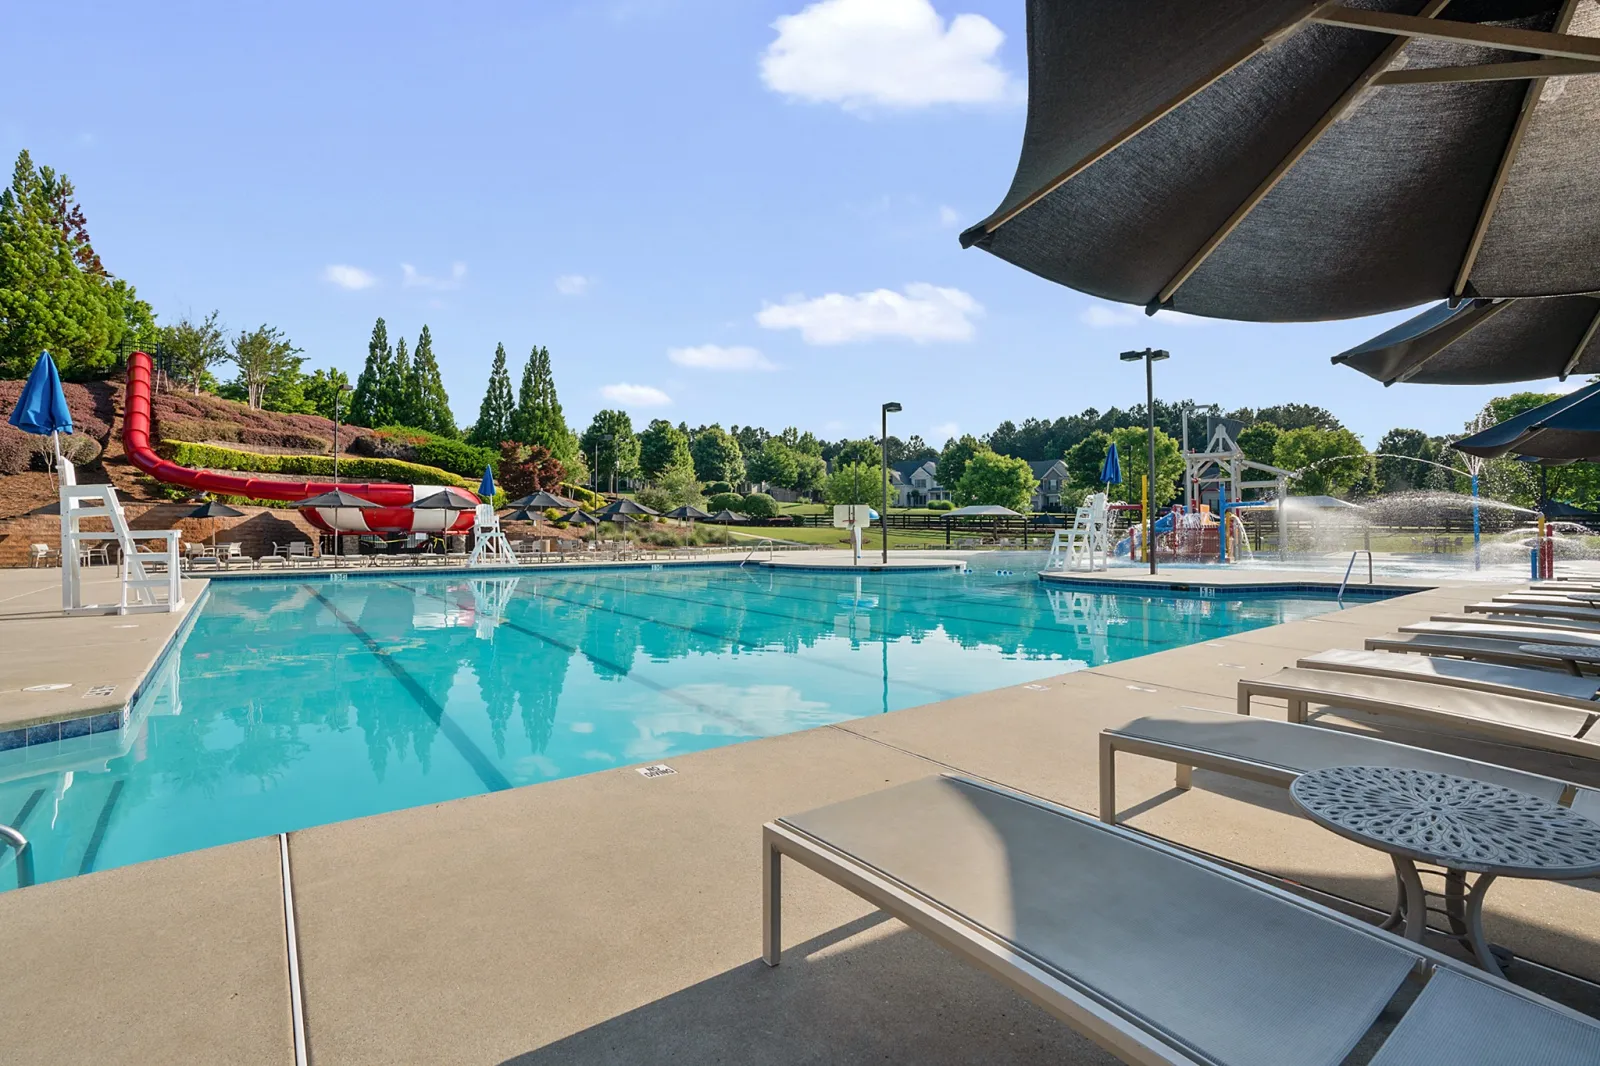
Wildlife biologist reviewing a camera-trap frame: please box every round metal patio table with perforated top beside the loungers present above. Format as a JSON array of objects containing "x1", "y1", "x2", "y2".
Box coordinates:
[{"x1": 1290, "y1": 767, "x2": 1600, "y2": 976}]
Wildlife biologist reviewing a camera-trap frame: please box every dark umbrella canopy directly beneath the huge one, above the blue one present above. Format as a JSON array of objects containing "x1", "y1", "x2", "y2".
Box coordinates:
[{"x1": 1333, "y1": 295, "x2": 1600, "y2": 386}]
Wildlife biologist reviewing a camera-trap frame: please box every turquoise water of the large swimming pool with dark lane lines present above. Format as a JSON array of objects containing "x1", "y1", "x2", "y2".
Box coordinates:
[{"x1": 0, "y1": 560, "x2": 1376, "y2": 888}]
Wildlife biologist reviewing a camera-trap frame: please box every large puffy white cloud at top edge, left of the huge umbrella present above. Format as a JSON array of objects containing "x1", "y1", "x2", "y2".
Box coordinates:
[{"x1": 762, "y1": 0, "x2": 1022, "y2": 110}]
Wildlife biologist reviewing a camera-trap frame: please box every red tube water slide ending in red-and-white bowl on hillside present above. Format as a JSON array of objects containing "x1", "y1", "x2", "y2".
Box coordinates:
[{"x1": 122, "y1": 352, "x2": 477, "y2": 533}]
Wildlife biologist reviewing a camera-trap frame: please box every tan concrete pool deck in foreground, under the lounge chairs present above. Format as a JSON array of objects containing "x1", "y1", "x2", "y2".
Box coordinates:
[{"x1": 0, "y1": 563, "x2": 1600, "y2": 1066}]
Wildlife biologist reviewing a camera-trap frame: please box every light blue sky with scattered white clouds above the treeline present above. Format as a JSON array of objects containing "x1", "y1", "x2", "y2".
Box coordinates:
[{"x1": 0, "y1": 0, "x2": 1554, "y2": 447}]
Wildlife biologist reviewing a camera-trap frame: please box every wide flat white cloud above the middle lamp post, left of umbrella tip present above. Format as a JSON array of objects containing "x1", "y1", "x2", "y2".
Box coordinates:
[{"x1": 755, "y1": 282, "x2": 984, "y2": 344}]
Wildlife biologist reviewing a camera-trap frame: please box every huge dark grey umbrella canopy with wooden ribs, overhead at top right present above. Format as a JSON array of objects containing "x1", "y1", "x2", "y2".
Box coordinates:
[{"x1": 962, "y1": 0, "x2": 1600, "y2": 322}]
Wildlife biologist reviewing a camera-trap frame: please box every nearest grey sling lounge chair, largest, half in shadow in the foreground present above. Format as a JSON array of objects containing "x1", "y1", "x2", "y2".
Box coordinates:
[{"x1": 762, "y1": 776, "x2": 1600, "y2": 1066}]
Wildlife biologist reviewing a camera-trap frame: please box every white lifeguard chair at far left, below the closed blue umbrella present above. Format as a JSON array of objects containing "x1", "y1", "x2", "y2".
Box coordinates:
[{"x1": 56, "y1": 456, "x2": 184, "y2": 615}]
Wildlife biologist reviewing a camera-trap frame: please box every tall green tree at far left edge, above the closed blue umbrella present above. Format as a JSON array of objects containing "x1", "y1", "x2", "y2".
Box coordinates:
[{"x1": 0, "y1": 150, "x2": 119, "y2": 378}]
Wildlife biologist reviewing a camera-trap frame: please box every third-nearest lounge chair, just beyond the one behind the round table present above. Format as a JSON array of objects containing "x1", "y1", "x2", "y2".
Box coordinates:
[{"x1": 1238, "y1": 667, "x2": 1600, "y2": 759}]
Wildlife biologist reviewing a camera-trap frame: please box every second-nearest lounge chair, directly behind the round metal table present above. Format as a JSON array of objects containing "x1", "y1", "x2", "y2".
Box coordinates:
[{"x1": 1099, "y1": 707, "x2": 1600, "y2": 824}]
